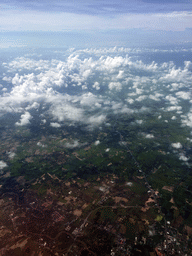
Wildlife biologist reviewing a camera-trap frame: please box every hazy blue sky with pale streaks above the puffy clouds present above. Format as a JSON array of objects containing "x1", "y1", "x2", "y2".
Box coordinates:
[{"x1": 0, "y1": 0, "x2": 192, "y2": 47}]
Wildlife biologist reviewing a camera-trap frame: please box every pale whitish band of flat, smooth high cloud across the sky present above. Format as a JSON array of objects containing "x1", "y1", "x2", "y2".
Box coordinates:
[{"x1": 0, "y1": 8, "x2": 192, "y2": 31}]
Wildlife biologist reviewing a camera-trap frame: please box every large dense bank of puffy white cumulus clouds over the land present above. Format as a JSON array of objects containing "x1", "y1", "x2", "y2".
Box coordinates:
[{"x1": 0, "y1": 47, "x2": 192, "y2": 135}]
